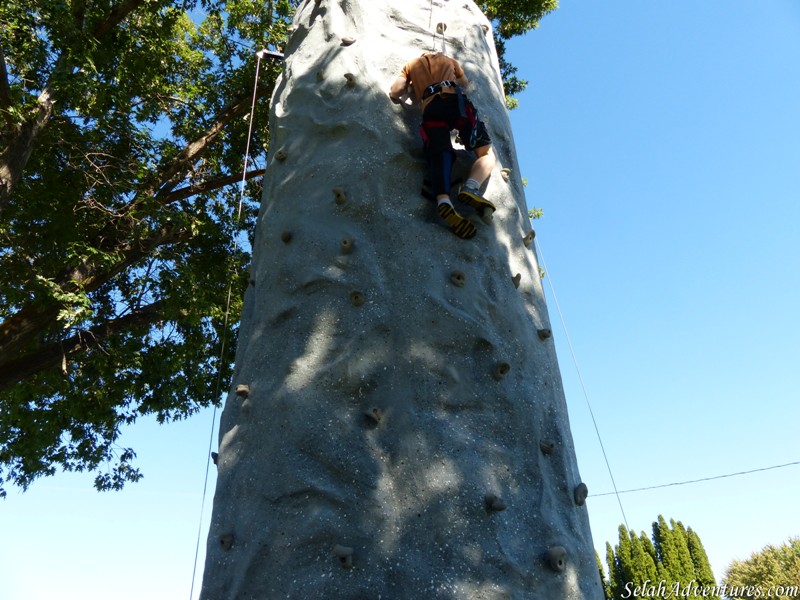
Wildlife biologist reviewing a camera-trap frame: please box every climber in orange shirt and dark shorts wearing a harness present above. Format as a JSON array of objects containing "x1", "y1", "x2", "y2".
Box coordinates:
[{"x1": 389, "y1": 52, "x2": 495, "y2": 239}]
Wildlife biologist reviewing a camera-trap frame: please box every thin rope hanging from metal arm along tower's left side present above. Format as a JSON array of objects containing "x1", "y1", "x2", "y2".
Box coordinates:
[{"x1": 189, "y1": 49, "x2": 268, "y2": 600}]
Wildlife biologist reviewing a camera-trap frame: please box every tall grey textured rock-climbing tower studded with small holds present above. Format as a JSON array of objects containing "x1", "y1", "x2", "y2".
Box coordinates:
[{"x1": 202, "y1": 0, "x2": 602, "y2": 600}]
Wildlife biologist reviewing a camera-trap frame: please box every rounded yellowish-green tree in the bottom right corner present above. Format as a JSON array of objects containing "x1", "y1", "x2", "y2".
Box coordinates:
[{"x1": 722, "y1": 537, "x2": 800, "y2": 598}]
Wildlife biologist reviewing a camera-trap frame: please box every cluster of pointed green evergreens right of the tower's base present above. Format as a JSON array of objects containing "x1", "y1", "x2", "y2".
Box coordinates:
[{"x1": 606, "y1": 515, "x2": 718, "y2": 600}]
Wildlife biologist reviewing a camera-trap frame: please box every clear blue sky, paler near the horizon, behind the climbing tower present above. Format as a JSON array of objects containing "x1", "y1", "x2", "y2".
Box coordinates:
[{"x1": 0, "y1": 0, "x2": 800, "y2": 600}]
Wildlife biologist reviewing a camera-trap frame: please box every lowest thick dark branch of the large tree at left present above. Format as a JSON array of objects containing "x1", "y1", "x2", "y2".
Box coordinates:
[{"x1": 0, "y1": 300, "x2": 165, "y2": 392}]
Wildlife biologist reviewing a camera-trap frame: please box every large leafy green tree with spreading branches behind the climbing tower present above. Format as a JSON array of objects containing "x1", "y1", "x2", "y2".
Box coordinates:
[{"x1": 0, "y1": 0, "x2": 553, "y2": 496}]
